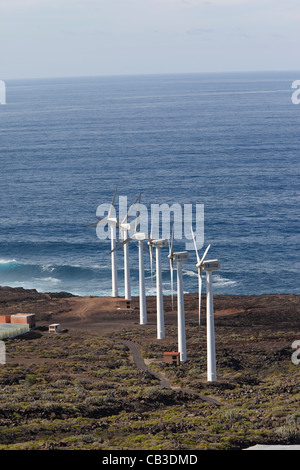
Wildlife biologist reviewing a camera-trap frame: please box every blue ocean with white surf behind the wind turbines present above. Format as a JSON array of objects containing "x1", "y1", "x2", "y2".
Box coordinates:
[{"x1": 0, "y1": 72, "x2": 300, "y2": 296}]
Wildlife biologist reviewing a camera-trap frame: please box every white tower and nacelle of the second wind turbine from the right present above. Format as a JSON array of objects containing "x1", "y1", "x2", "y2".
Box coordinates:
[{"x1": 173, "y1": 251, "x2": 189, "y2": 362}]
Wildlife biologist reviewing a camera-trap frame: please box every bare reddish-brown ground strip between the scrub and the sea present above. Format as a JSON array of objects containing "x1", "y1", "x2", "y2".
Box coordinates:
[{"x1": 0, "y1": 287, "x2": 300, "y2": 344}]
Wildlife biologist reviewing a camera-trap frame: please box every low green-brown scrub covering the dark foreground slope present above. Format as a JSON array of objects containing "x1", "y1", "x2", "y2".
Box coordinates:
[{"x1": 0, "y1": 306, "x2": 300, "y2": 450}]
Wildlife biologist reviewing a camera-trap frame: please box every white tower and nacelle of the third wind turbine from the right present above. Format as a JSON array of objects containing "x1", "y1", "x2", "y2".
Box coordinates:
[{"x1": 148, "y1": 236, "x2": 168, "y2": 339}]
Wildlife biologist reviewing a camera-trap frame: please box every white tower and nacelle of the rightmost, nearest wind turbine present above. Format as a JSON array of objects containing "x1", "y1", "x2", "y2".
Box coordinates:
[{"x1": 203, "y1": 259, "x2": 220, "y2": 382}]
